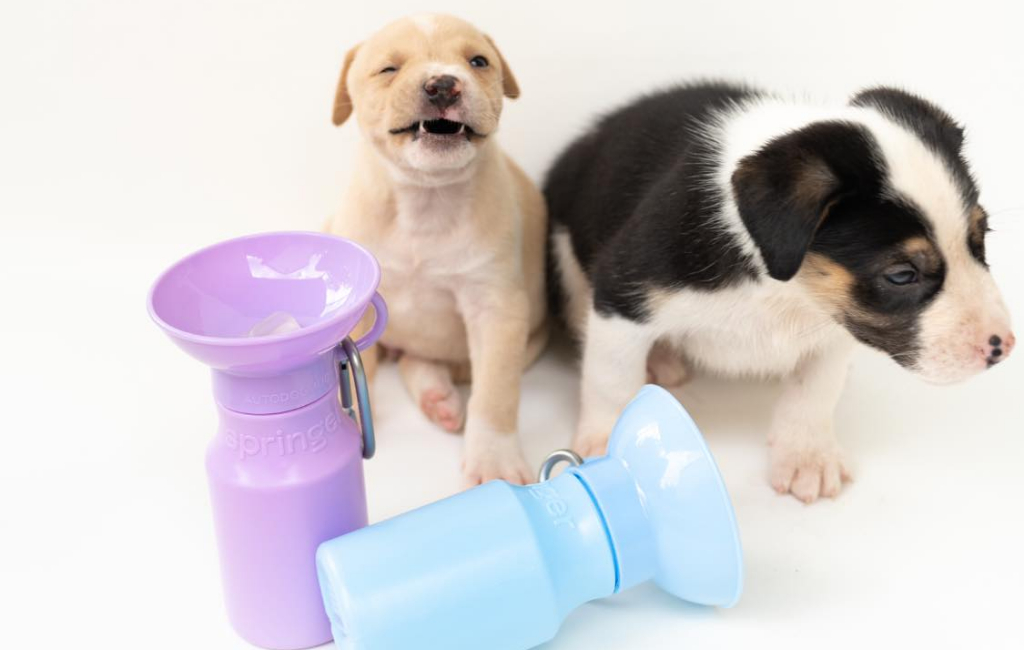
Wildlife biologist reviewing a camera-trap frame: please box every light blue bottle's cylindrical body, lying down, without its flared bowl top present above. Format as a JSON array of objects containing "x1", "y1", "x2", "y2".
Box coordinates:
[{"x1": 316, "y1": 475, "x2": 615, "y2": 650}]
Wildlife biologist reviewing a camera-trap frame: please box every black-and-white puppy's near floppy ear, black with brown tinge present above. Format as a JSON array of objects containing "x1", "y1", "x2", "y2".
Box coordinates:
[{"x1": 732, "y1": 122, "x2": 882, "y2": 280}]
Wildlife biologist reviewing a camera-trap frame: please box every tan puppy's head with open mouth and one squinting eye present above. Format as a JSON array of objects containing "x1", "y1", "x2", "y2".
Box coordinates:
[{"x1": 334, "y1": 15, "x2": 519, "y2": 174}]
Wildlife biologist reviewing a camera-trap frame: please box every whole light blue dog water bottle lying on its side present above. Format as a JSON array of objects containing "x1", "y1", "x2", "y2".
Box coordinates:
[{"x1": 316, "y1": 386, "x2": 742, "y2": 650}]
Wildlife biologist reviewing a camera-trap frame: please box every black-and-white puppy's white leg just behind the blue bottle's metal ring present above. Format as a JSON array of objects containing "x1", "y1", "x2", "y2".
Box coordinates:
[{"x1": 572, "y1": 307, "x2": 656, "y2": 458}]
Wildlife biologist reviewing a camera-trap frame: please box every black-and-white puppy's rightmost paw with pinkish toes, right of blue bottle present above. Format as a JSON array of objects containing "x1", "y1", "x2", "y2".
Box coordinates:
[{"x1": 771, "y1": 436, "x2": 853, "y2": 504}]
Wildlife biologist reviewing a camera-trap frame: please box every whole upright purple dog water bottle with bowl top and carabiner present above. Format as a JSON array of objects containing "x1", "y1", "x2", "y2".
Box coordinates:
[{"x1": 148, "y1": 232, "x2": 387, "y2": 650}]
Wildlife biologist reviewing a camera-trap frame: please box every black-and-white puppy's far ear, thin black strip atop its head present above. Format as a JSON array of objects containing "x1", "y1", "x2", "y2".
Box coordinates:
[{"x1": 850, "y1": 86, "x2": 964, "y2": 156}]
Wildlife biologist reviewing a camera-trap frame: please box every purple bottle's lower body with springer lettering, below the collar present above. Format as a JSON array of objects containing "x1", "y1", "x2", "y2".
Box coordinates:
[{"x1": 207, "y1": 390, "x2": 367, "y2": 650}]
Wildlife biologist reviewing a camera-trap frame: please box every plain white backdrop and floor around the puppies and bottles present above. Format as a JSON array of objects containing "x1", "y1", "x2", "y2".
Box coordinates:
[{"x1": 0, "y1": 0, "x2": 1024, "y2": 650}]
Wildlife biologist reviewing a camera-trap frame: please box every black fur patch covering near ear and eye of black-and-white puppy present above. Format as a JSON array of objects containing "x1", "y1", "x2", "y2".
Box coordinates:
[{"x1": 732, "y1": 114, "x2": 945, "y2": 365}]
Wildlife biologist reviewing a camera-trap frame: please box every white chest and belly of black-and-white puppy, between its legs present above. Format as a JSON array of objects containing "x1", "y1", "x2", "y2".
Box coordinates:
[{"x1": 655, "y1": 285, "x2": 848, "y2": 376}]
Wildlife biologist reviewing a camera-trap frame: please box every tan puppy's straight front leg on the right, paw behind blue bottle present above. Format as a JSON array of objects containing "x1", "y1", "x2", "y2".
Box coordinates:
[{"x1": 460, "y1": 287, "x2": 532, "y2": 486}]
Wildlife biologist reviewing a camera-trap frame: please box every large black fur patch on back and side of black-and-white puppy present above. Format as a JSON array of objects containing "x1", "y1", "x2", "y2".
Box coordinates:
[{"x1": 544, "y1": 84, "x2": 757, "y2": 320}]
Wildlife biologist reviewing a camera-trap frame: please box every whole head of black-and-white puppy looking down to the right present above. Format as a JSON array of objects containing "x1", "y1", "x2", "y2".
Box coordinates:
[{"x1": 733, "y1": 89, "x2": 1015, "y2": 383}]
